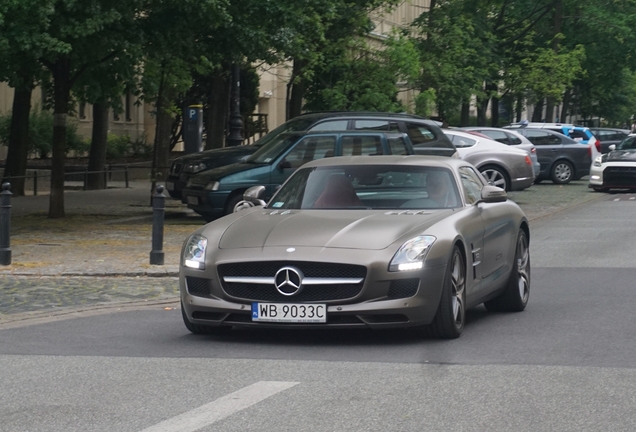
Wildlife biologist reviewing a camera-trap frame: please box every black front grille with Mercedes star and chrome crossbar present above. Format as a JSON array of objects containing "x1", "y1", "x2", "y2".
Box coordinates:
[{"x1": 218, "y1": 261, "x2": 367, "y2": 302}]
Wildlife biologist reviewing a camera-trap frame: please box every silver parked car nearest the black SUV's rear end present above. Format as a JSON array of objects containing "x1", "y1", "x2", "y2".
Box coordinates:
[{"x1": 444, "y1": 129, "x2": 535, "y2": 191}]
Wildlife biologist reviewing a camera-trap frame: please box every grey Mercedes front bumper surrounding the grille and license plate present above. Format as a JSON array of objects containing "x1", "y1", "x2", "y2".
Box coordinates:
[{"x1": 179, "y1": 248, "x2": 446, "y2": 328}]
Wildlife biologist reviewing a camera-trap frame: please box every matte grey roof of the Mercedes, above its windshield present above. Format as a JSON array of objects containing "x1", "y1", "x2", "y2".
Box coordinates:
[{"x1": 303, "y1": 155, "x2": 464, "y2": 170}]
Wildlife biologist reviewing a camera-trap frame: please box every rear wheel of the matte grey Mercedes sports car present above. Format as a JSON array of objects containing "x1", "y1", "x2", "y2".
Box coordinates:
[{"x1": 484, "y1": 230, "x2": 530, "y2": 312}]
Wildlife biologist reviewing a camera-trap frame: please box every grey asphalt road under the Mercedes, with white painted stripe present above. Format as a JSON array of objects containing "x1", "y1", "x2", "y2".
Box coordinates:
[{"x1": 0, "y1": 186, "x2": 636, "y2": 432}]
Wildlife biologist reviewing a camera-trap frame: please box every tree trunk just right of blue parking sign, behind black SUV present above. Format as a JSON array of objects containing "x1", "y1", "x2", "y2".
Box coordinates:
[{"x1": 205, "y1": 68, "x2": 230, "y2": 150}]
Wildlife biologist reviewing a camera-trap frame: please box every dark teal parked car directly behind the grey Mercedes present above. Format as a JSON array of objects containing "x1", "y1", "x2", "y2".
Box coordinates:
[{"x1": 182, "y1": 131, "x2": 415, "y2": 221}]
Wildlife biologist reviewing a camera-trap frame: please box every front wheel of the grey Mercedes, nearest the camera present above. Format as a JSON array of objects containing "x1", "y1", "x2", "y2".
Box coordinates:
[{"x1": 424, "y1": 246, "x2": 466, "y2": 339}]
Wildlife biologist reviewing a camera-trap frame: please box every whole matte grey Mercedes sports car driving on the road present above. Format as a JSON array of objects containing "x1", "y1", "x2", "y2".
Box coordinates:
[{"x1": 179, "y1": 156, "x2": 530, "y2": 338}]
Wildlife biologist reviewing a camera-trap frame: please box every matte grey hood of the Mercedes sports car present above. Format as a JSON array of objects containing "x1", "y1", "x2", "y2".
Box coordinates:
[{"x1": 219, "y1": 209, "x2": 454, "y2": 250}]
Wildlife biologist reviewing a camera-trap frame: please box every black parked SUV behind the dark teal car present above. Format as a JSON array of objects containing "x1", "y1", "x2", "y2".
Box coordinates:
[{"x1": 166, "y1": 111, "x2": 457, "y2": 202}]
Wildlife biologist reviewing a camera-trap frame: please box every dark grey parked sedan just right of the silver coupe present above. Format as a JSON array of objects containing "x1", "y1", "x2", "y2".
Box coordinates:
[{"x1": 515, "y1": 128, "x2": 594, "y2": 184}]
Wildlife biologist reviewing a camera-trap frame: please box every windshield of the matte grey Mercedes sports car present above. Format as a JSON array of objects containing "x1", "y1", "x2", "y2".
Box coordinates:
[{"x1": 267, "y1": 165, "x2": 461, "y2": 210}]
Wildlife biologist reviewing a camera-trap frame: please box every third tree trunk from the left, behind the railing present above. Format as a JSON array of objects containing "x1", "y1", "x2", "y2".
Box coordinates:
[{"x1": 86, "y1": 102, "x2": 108, "y2": 190}]
